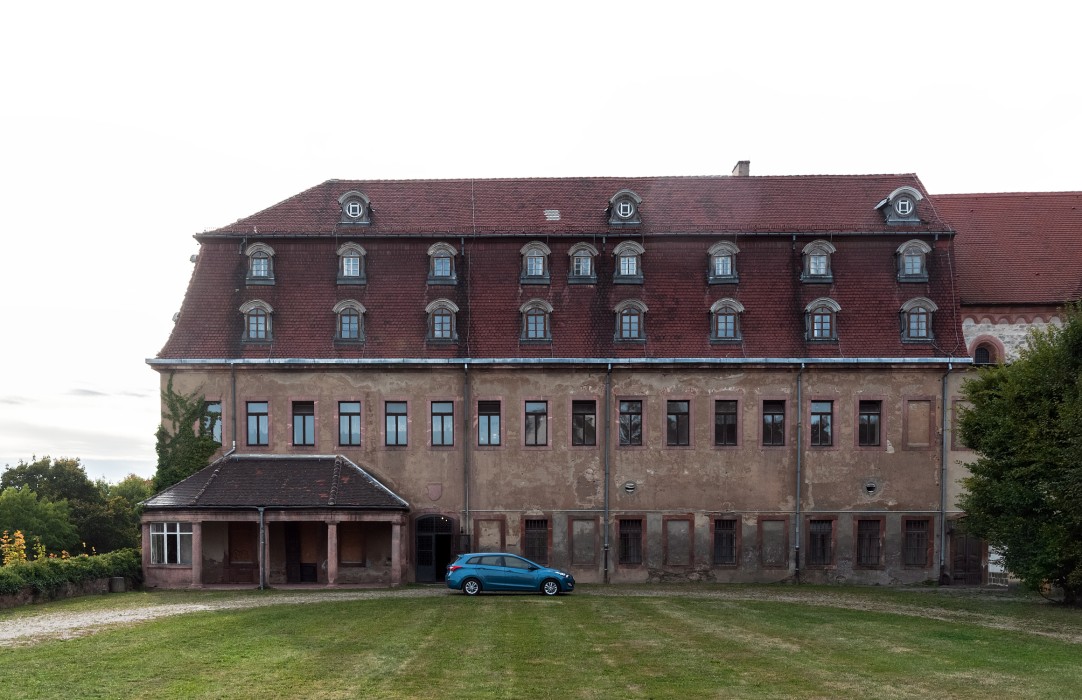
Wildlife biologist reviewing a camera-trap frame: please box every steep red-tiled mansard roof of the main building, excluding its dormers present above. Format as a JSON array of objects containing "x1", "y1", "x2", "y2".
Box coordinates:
[{"x1": 159, "y1": 175, "x2": 965, "y2": 359}]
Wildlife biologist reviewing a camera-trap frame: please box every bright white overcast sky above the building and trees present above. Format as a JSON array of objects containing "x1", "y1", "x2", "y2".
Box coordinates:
[{"x1": 0, "y1": 0, "x2": 1082, "y2": 481}]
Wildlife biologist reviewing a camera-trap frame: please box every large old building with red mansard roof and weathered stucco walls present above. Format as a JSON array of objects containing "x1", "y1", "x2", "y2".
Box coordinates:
[{"x1": 144, "y1": 175, "x2": 979, "y2": 585}]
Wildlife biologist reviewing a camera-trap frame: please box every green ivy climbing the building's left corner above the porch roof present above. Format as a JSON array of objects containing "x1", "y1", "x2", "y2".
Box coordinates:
[{"x1": 154, "y1": 375, "x2": 221, "y2": 491}]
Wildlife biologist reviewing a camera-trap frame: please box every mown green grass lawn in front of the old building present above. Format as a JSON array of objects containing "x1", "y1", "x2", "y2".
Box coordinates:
[{"x1": 0, "y1": 584, "x2": 1082, "y2": 699}]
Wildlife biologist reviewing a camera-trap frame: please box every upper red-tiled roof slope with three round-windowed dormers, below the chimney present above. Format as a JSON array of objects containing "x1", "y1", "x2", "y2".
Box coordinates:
[{"x1": 201, "y1": 174, "x2": 944, "y2": 237}]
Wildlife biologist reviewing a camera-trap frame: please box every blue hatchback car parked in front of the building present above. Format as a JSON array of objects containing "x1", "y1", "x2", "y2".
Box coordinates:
[{"x1": 447, "y1": 552, "x2": 575, "y2": 595}]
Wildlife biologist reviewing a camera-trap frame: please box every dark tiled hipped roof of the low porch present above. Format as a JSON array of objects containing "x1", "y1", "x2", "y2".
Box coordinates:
[{"x1": 145, "y1": 454, "x2": 409, "y2": 511}]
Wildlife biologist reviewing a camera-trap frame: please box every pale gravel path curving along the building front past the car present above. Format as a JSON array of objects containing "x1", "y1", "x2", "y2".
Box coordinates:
[{"x1": 0, "y1": 586, "x2": 1082, "y2": 648}]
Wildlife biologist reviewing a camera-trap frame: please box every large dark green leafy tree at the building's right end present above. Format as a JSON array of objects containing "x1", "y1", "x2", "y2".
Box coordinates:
[{"x1": 959, "y1": 303, "x2": 1082, "y2": 605}]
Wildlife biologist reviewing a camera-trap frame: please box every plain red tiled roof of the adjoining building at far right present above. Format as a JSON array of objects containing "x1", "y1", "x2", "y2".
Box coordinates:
[{"x1": 935, "y1": 191, "x2": 1082, "y2": 304}]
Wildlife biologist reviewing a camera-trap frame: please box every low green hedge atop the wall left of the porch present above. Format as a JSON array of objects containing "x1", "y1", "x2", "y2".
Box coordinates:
[{"x1": 0, "y1": 550, "x2": 143, "y2": 595}]
